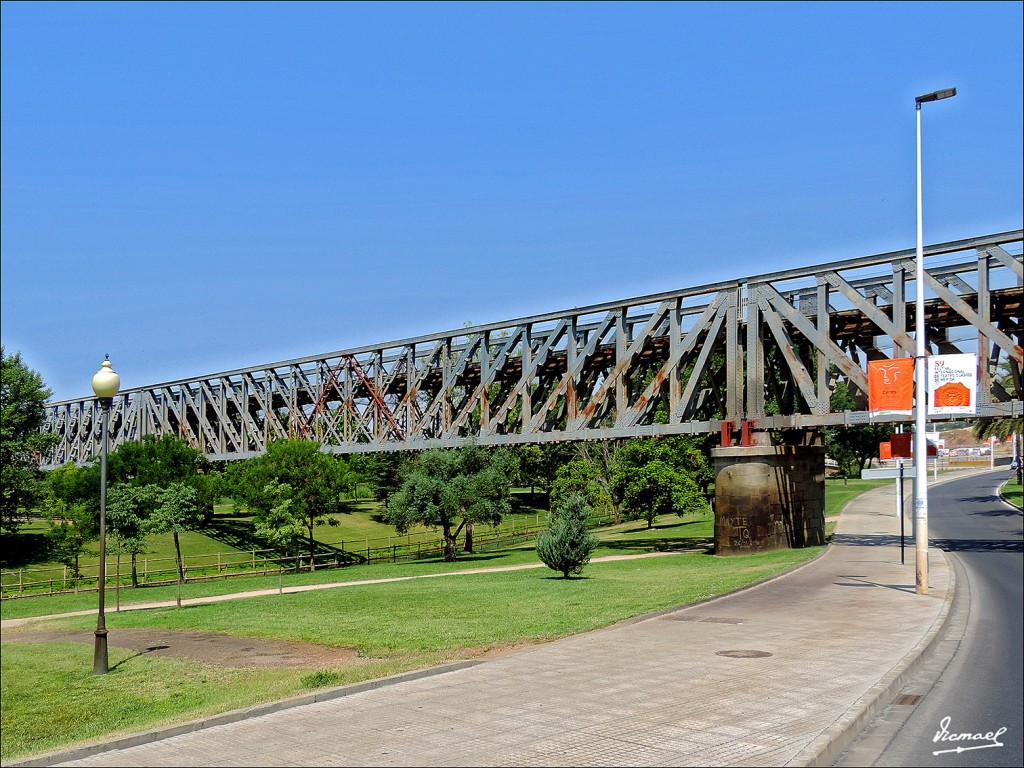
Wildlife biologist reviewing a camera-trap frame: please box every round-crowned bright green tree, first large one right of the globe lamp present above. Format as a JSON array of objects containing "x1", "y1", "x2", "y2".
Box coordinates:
[{"x1": 228, "y1": 440, "x2": 352, "y2": 569}]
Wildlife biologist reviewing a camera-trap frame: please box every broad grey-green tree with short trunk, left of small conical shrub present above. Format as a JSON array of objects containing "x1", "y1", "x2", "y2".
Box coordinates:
[{"x1": 385, "y1": 443, "x2": 516, "y2": 562}]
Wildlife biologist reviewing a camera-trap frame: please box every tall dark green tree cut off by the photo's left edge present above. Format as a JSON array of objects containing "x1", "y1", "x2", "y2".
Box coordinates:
[{"x1": 0, "y1": 346, "x2": 57, "y2": 537}]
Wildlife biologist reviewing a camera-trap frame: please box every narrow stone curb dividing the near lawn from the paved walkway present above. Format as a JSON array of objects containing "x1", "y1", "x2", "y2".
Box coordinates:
[{"x1": 4, "y1": 659, "x2": 483, "y2": 768}]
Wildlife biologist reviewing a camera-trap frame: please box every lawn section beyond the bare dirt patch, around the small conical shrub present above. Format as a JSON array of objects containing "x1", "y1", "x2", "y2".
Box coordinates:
[{"x1": 54, "y1": 548, "x2": 822, "y2": 657}]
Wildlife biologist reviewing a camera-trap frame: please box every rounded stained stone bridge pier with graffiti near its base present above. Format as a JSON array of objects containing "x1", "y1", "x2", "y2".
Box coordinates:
[{"x1": 712, "y1": 445, "x2": 825, "y2": 555}]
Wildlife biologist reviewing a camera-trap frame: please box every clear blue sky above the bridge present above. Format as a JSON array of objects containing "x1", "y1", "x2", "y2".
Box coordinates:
[{"x1": 0, "y1": 2, "x2": 1024, "y2": 399}]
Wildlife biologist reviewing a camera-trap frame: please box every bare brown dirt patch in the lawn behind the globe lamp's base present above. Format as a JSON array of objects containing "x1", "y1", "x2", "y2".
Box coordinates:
[{"x1": 3, "y1": 629, "x2": 368, "y2": 669}]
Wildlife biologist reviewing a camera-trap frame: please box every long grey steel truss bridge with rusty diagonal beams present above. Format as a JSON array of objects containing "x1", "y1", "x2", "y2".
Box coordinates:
[{"x1": 42, "y1": 229, "x2": 1024, "y2": 467}]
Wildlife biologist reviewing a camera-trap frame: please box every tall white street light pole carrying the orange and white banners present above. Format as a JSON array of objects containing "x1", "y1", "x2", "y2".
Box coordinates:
[{"x1": 913, "y1": 88, "x2": 956, "y2": 595}]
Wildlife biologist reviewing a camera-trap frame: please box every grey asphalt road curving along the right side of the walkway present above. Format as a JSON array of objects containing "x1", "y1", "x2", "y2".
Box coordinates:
[{"x1": 838, "y1": 470, "x2": 1024, "y2": 766}]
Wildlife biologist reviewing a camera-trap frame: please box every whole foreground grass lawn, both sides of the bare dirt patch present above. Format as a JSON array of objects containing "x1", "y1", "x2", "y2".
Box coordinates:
[{"x1": 0, "y1": 548, "x2": 822, "y2": 760}]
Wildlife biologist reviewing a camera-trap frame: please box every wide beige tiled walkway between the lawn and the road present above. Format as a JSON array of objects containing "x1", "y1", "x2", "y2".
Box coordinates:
[{"x1": 16, "y1": 473, "x2": 966, "y2": 766}]
